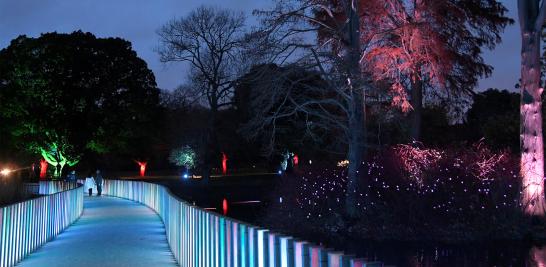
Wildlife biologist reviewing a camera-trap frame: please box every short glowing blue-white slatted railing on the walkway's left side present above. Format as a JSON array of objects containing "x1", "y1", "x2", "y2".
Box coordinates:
[{"x1": 0, "y1": 182, "x2": 83, "y2": 267}]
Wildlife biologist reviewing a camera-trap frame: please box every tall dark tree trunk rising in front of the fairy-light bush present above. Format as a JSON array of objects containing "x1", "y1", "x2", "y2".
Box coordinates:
[{"x1": 345, "y1": 0, "x2": 366, "y2": 217}]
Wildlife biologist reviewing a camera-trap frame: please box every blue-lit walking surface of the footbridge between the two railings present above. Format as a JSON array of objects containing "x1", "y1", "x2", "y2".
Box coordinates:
[{"x1": 17, "y1": 196, "x2": 176, "y2": 267}]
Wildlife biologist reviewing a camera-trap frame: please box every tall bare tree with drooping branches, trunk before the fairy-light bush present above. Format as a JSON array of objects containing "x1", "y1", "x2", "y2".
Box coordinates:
[{"x1": 246, "y1": 0, "x2": 371, "y2": 218}]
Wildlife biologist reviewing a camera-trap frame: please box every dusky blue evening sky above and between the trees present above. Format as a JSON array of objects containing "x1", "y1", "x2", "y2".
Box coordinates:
[{"x1": 0, "y1": 0, "x2": 521, "y2": 90}]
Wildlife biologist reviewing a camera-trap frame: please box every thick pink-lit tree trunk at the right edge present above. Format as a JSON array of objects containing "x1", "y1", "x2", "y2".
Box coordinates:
[{"x1": 518, "y1": 0, "x2": 546, "y2": 216}]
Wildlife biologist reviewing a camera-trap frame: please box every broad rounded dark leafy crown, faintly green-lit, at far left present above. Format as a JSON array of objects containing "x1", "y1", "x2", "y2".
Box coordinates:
[{"x1": 0, "y1": 32, "x2": 159, "y2": 172}]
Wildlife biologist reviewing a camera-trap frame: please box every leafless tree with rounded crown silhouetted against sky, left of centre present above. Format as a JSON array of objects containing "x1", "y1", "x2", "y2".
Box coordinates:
[{"x1": 158, "y1": 6, "x2": 245, "y2": 178}]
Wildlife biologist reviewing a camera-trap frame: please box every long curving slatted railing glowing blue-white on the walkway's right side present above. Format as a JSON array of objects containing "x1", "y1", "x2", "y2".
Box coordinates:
[{"x1": 104, "y1": 180, "x2": 383, "y2": 267}]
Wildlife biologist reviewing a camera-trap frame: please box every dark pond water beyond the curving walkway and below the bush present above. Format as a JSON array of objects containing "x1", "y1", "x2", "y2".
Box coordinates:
[{"x1": 150, "y1": 176, "x2": 546, "y2": 267}]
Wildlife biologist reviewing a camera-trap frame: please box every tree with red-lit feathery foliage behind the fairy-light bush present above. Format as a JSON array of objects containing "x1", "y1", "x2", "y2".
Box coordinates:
[{"x1": 361, "y1": 0, "x2": 512, "y2": 140}]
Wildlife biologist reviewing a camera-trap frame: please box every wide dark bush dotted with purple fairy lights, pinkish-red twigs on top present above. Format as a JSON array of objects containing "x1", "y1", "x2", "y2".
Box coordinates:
[{"x1": 260, "y1": 144, "x2": 529, "y2": 244}]
